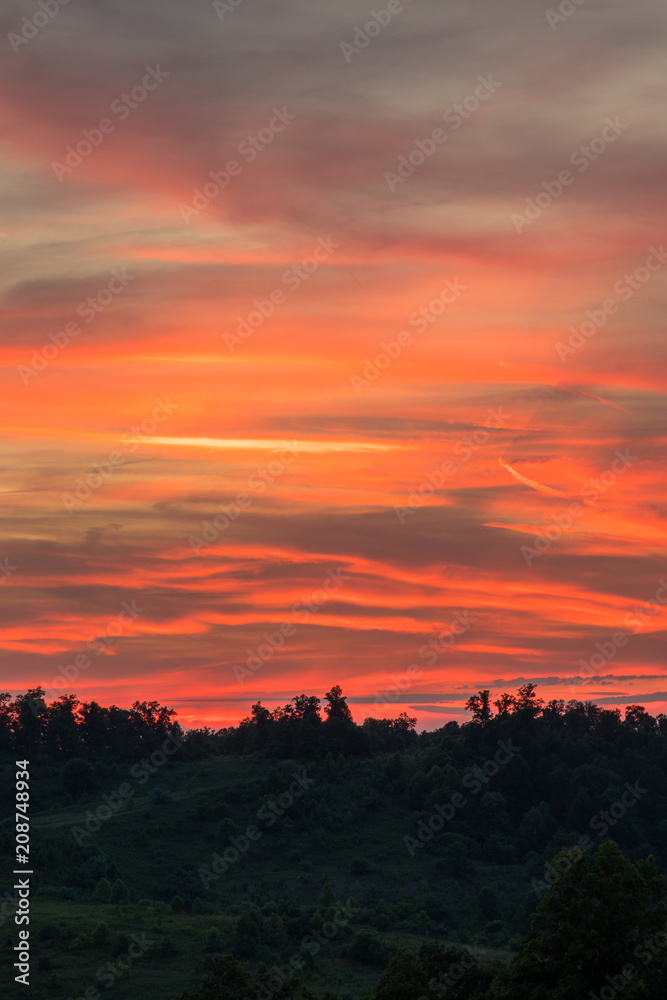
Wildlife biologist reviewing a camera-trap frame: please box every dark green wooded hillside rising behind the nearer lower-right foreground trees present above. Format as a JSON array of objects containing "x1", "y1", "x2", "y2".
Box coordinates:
[{"x1": 0, "y1": 686, "x2": 667, "y2": 1000}]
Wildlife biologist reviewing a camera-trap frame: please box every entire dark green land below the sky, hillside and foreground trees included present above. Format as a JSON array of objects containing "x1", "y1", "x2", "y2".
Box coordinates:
[{"x1": 0, "y1": 684, "x2": 667, "y2": 1000}]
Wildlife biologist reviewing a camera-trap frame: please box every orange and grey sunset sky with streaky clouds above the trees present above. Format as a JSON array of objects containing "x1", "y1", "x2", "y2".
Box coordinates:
[{"x1": 0, "y1": 0, "x2": 667, "y2": 729}]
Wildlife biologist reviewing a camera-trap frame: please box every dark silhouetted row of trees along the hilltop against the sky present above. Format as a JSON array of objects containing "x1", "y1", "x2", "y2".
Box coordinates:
[{"x1": 0, "y1": 684, "x2": 667, "y2": 761}]
